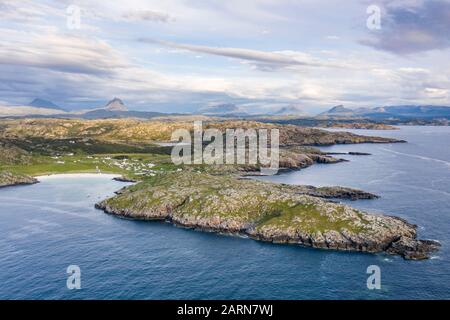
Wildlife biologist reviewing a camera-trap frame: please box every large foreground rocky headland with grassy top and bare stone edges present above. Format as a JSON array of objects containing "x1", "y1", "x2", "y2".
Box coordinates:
[{"x1": 96, "y1": 172, "x2": 437, "y2": 259}]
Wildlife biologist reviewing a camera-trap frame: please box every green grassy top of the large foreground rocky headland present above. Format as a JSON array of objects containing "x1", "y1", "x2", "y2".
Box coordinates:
[{"x1": 99, "y1": 171, "x2": 368, "y2": 233}]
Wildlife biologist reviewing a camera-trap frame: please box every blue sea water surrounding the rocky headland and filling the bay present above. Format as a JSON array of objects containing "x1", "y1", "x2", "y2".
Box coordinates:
[{"x1": 0, "y1": 127, "x2": 450, "y2": 299}]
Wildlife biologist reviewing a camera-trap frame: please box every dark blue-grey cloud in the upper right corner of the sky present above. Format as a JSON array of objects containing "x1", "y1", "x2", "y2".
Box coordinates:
[{"x1": 360, "y1": 0, "x2": 450, "y2": 54}]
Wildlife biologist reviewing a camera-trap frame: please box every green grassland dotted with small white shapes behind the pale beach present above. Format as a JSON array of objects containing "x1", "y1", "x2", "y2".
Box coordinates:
[{"x1": 0, "y1": 132, "x2": 177, "y2": 179}]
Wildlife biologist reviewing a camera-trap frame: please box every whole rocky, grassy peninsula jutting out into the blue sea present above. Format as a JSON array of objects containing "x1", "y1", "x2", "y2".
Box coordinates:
[{"x1": 0, "y1": 119, "x2": 439, "y2": 259}]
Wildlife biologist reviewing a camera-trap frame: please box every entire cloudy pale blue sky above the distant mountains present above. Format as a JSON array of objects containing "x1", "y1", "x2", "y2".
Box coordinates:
[{"x1": 0, "y1": 0, "x2": 450, "y2": 114}]
